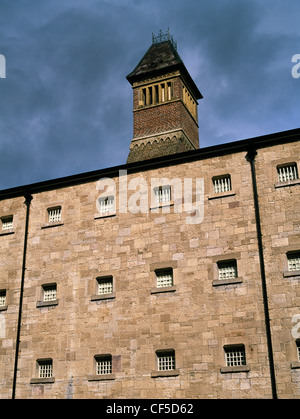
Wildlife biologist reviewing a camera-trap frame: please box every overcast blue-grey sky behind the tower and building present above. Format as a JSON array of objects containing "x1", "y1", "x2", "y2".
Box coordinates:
[{"x1": 0, "y1": 0, "x2": 300, "y2": 189}]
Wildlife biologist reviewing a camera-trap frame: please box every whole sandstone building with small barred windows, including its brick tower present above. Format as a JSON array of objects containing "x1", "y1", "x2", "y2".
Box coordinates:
[{"x1": 0, "y1": 31, "x2": 300, "y2": 399}]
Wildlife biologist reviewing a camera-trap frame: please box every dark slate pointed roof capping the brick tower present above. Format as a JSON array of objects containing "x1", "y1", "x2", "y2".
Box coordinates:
[{"x1": 126, "y1": 41, "x2": 202, "y2": 99}]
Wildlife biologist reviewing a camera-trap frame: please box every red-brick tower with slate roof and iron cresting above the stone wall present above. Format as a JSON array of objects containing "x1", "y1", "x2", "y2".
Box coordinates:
[{"x1": 127, "y1": 31, "x2": 202, "y2": 163}]
